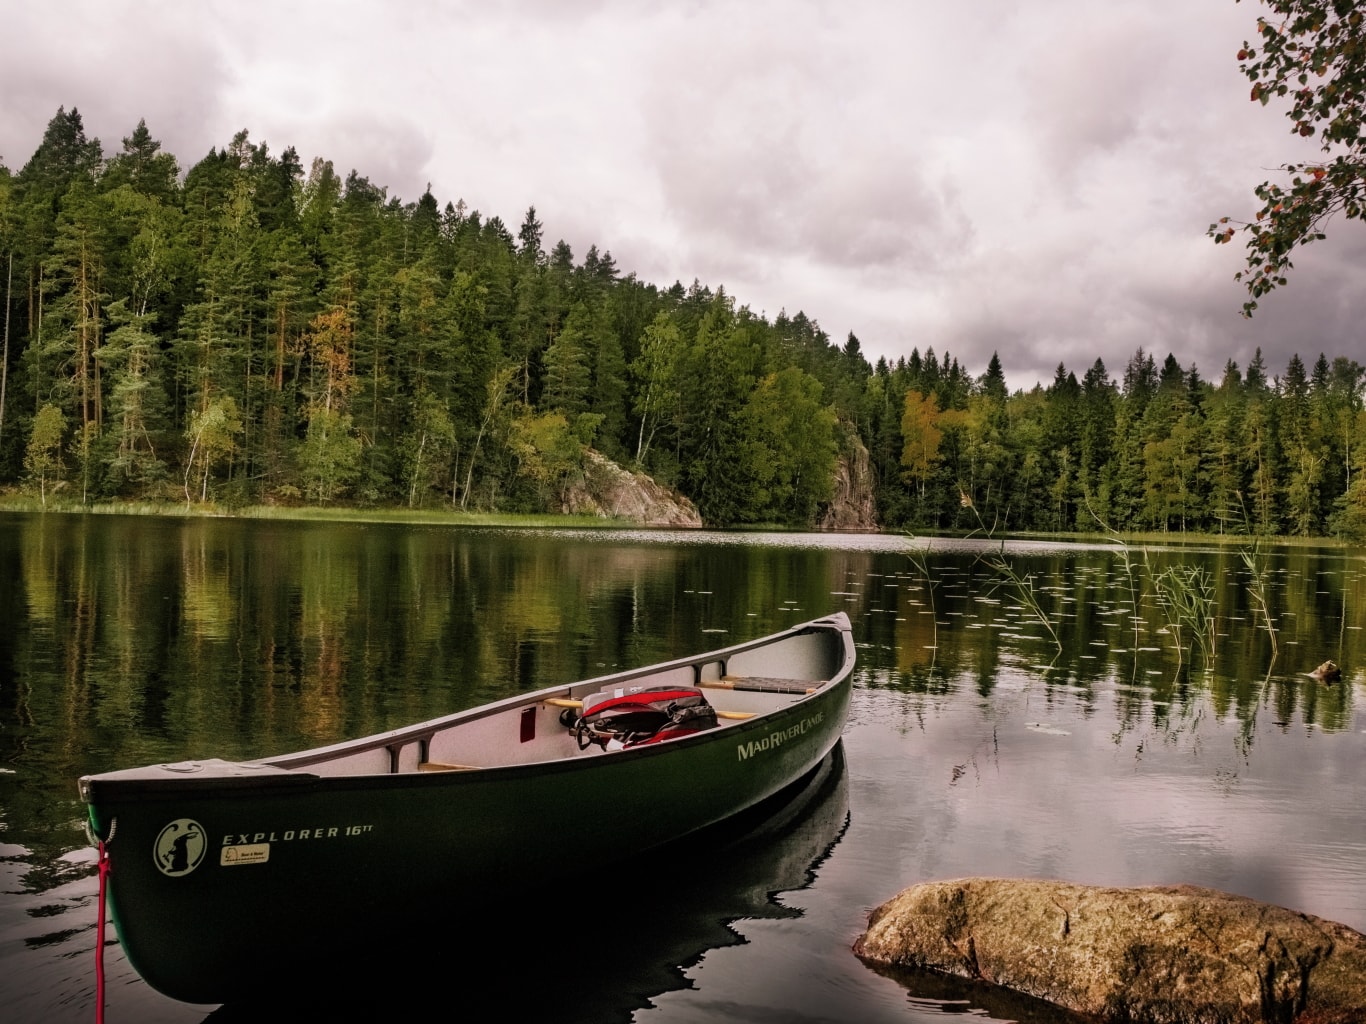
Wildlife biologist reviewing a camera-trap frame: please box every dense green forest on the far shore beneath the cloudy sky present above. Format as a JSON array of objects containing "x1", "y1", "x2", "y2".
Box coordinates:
[{"x1": 0, "y1": 108, "x2": 1366, "y2": 539}]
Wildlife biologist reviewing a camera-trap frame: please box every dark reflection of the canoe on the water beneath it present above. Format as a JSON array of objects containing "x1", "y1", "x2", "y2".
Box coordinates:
[{"x1": 206, "y1": 744, "x2": 848, "y2": 1024}]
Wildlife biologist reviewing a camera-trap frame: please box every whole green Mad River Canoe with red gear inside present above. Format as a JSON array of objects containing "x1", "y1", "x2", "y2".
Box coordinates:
[{"x1": 79, "y1": 613, "x2": 854, "y2": 1002}]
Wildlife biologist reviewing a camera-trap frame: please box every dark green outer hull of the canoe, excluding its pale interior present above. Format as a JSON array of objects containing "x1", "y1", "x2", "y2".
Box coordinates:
[{"x1": 82, "y1": 616, "x2": 852, "y2": 1002}]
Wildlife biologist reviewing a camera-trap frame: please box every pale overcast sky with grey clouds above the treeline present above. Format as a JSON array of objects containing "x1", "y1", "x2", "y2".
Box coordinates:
[{"x1": 0, "y1": 0, "x2": 1366, "y2": 388}]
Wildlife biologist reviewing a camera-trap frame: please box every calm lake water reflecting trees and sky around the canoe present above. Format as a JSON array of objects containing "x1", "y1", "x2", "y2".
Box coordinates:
[{"x1": 0, "y1": 513, "x2": 1366, "y2": 1024}]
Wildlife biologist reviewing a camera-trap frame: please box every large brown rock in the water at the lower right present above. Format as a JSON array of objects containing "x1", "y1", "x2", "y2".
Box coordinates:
[{"x1": 854, "y1": 878, "x2": 1366, "y2": 1024}]
